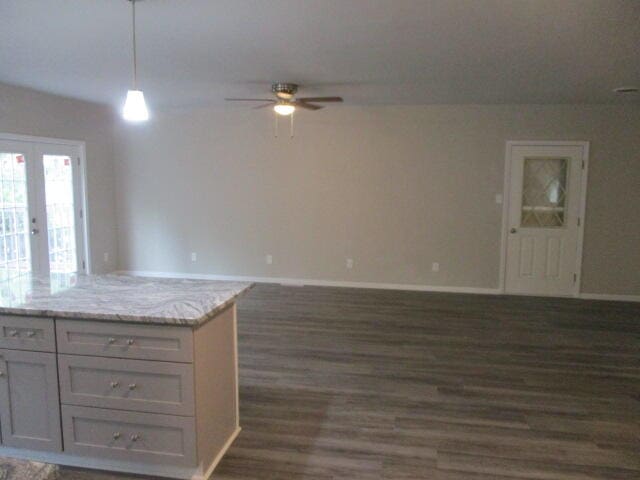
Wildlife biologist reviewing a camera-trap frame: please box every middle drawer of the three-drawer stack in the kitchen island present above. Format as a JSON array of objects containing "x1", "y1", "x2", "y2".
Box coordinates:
[{"x1": 58, "y1": 355, "x2": 194, "y2": 415}]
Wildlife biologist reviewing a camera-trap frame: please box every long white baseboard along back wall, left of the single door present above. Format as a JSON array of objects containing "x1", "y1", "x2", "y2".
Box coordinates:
[{"x1": 114, "y1": 270, "x2": 501, "y2": 295}]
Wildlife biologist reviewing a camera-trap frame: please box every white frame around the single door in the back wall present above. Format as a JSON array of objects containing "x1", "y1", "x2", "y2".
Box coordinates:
[{"x1": 499, "y1": 140, "x2": 589, "y2": 297}]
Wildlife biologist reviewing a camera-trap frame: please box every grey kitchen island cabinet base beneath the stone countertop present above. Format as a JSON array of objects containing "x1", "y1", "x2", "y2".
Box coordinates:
[{"x1": 0, "y1": 304, "x2": 240, "y2": 480}]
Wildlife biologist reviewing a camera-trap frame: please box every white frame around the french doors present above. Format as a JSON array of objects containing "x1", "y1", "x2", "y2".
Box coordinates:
[{"x1": 0, "y1": 132, "x2": 91, "y2": 274}]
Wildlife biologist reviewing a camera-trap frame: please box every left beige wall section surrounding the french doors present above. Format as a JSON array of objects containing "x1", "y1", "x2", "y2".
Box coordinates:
[{"x1": 0, "y1": 80, "x2": 117, "y2": 273}]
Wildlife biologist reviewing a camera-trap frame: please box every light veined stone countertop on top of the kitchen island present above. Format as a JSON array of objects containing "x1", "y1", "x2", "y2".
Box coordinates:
[{"x1": 0, "y1": 274, "x2": 252, "y2": 327}]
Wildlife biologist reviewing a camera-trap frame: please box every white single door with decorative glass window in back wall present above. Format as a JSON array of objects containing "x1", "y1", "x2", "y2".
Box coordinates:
[{"x1": 505, "y1": 144, "x2": 586, "y2": 296}]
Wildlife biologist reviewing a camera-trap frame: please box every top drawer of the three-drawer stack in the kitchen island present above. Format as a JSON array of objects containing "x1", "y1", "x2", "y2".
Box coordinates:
[{"x1": 56, "y1": 320, "x2": 193, "y2": 362}]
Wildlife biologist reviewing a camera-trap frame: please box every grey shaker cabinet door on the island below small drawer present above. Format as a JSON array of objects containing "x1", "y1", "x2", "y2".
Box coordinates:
[{"x1": 0, "y1": 349, "x2": 62, "y2": 452}]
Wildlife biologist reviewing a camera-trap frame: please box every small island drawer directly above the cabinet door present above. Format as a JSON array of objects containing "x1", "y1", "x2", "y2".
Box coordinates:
[{"x1": 0, "y1": 315, "x2": 56, "y2": 352}]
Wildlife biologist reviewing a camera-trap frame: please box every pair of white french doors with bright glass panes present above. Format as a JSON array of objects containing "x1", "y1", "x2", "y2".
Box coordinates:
[{"x1": 0, "y1": 138, "x2": 85, "y2": 280}]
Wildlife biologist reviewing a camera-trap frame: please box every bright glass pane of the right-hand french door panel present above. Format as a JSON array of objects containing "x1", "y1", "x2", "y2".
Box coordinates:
[{"x1": 42, "y1": 155, "x2": 78, "y2": 273}]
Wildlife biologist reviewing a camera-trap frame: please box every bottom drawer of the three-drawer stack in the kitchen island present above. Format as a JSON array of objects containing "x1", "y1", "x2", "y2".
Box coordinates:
[{"x1": 62, "y1": 405, "x2": 196, "y2": 466}]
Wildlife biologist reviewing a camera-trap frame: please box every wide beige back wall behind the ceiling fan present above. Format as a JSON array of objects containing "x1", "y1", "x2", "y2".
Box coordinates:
[{"x1": 116, "y1": 106, "x2": 640, "y2": 295}]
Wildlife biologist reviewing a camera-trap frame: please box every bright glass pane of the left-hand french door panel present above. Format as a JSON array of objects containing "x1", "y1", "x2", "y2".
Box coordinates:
[{"x1": 0, "y1": 152, "x2": 31, "y2": 280}]
